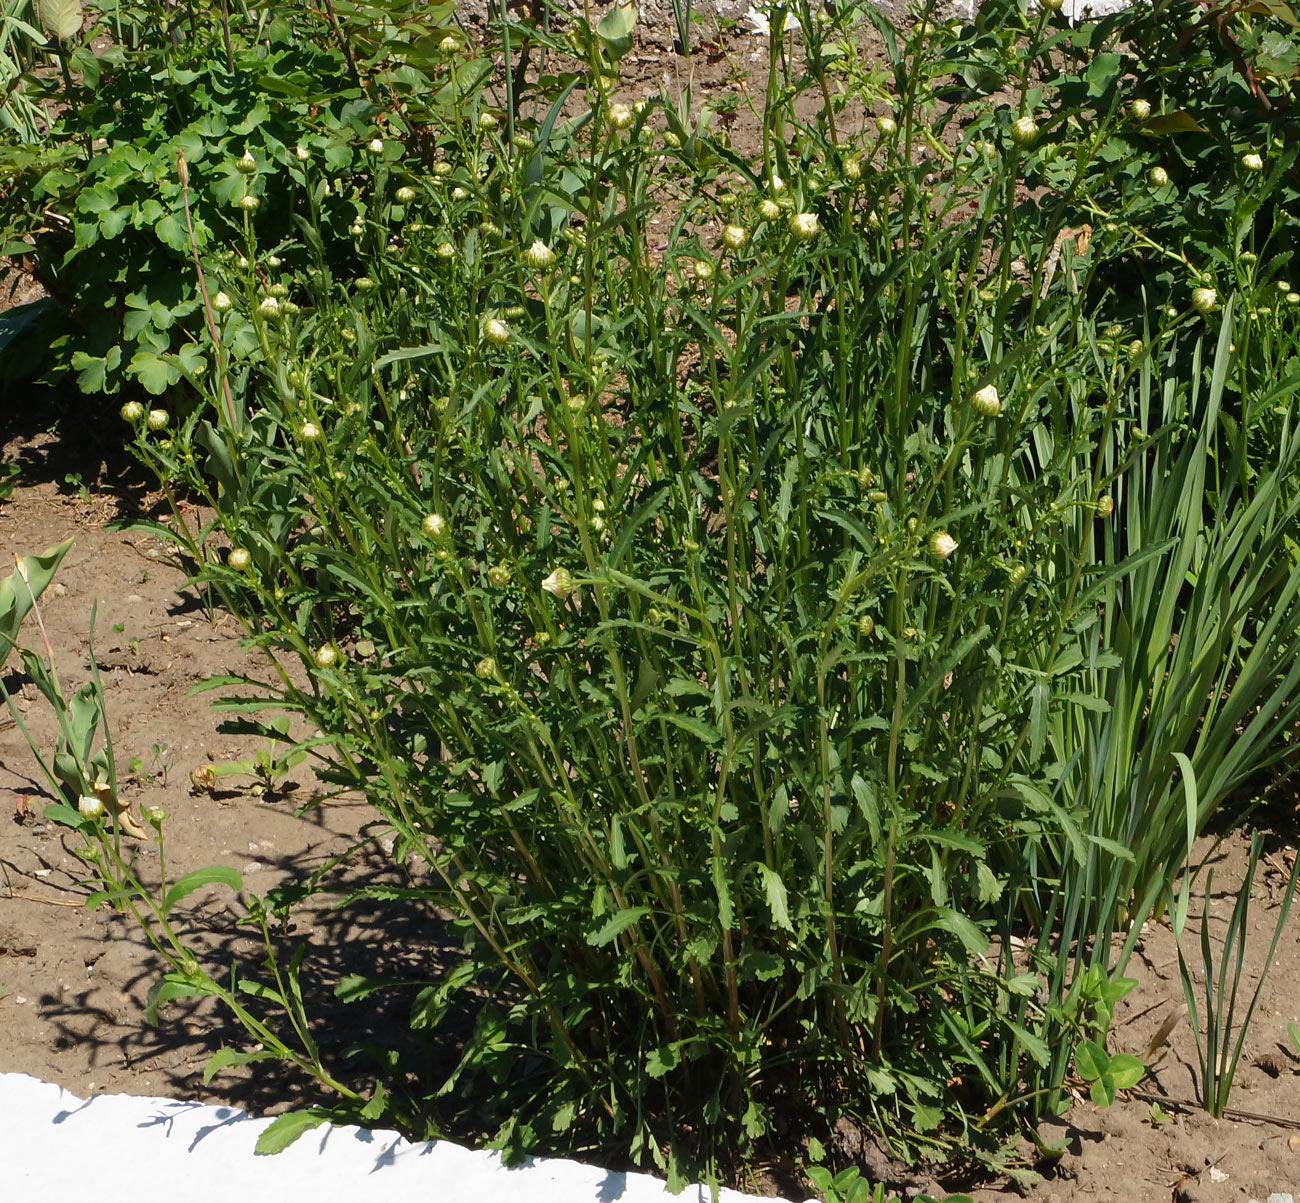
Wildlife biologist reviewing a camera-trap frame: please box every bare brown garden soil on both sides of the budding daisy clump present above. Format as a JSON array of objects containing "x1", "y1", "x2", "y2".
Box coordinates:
[{"x1": 0, "y1": 421, "x2": 1300, "y2": 1203}]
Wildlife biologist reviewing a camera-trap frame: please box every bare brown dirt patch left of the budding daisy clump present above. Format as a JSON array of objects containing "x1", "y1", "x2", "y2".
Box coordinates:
[{"x1": 0, "y1": 421, "x2": 462, "y2": 1111}]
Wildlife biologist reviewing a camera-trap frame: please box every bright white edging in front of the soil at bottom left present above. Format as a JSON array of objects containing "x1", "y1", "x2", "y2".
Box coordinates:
[{"x1": 0, "y1": 1073, "x2": 811, "y2": 1203}]
